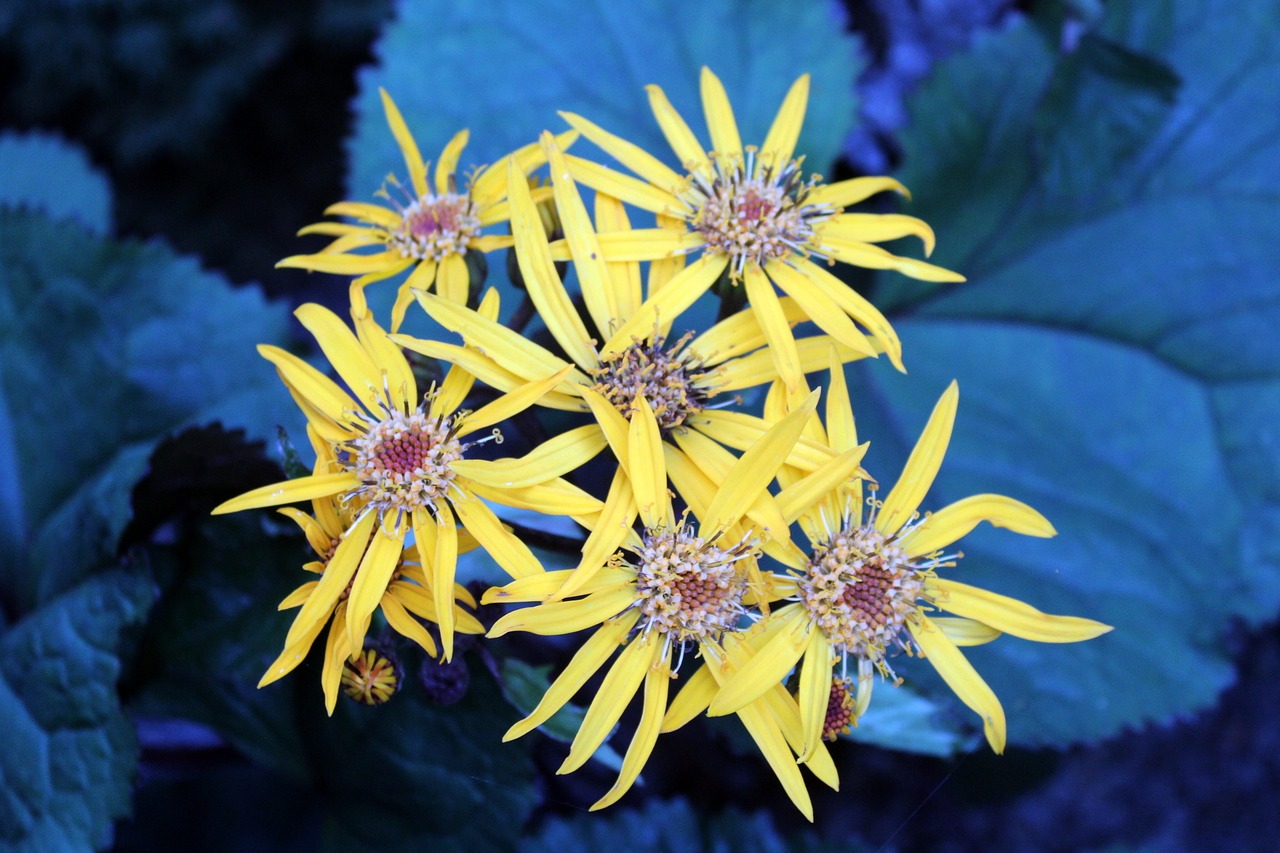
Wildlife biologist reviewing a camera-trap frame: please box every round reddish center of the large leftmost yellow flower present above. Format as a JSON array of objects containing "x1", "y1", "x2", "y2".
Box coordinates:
[{"x1": 346, "y1": 407, "x2": 465, "y2": 514}]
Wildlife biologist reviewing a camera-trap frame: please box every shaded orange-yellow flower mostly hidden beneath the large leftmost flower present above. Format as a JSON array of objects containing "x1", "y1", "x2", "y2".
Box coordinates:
[{"x1": 259, "y1": 428, "x2": 484, "y2": 713}]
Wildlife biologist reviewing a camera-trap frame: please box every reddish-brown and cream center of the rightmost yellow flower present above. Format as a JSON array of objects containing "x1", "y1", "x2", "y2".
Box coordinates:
[{"x1": 799, "y1": 525, "x2": 933, "y2": 670}]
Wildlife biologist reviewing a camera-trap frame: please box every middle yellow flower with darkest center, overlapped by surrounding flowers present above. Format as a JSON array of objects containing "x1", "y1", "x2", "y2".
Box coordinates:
[{"x1": 392, "y1": 133, "x2": 874, "y2": 594}]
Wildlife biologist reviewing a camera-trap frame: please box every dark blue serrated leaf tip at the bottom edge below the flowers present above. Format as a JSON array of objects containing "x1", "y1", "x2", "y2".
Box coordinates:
[{"x1": 520, "y1": 799, "x2": 863, "y2": 853}]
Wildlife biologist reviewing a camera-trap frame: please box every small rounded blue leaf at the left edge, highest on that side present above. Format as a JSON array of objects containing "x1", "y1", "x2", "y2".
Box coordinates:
[{"x1": 0, "y1": 133, "x2": 111, "y2": 234}]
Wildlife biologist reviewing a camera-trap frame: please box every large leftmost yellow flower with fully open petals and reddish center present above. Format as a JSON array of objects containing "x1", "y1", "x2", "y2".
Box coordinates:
[{"x1": 214, "y1": 284, "x2": 600, "y2": 658}]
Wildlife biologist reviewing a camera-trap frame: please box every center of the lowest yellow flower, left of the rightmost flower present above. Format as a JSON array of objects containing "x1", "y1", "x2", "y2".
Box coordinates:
[{"x1": 636, "y1": 521, "x2": 756, "y2": 643}]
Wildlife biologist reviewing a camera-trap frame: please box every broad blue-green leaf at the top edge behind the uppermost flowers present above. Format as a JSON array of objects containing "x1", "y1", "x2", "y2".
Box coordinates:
[{"x1": 349, "y1": 0, "x2": 860, "y2": 200}]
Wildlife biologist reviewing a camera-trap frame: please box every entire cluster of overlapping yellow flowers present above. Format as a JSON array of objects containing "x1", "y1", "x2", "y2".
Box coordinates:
[{"x1": 216, "y1": 69, "x2": 1108, "y2": 818}]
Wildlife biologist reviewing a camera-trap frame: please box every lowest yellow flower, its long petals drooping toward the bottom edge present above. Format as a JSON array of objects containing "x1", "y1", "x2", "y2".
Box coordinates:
[{"x1": 483, "y1": 397, "x2": 847, "y2": 820}]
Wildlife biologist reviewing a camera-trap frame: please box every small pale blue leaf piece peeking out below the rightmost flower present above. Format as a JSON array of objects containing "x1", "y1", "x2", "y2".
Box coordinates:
[{"x1": 842, "y1": 681, "x2": 972, "y2": 757}]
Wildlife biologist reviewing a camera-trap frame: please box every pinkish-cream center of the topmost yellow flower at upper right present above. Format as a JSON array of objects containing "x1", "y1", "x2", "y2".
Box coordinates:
[{"x1": 685, "y1": 150, "x2": 835, "y2": 278}]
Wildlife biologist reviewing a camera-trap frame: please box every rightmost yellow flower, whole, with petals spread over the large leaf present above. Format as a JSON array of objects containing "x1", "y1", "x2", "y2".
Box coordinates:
[{"x1": 709, "y1": 366, "x2": 1111, "y2": 761}]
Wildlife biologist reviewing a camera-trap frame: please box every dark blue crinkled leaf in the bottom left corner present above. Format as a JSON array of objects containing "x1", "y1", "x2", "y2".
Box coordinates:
[{"x1": 0, "y1": 563, "x2": 154, "y2": 852}]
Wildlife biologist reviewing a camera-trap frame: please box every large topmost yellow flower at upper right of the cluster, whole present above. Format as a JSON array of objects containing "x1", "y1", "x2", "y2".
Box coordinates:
[{"x1": 562, "y1": 68, "x2": 964, "y2": 391}]
